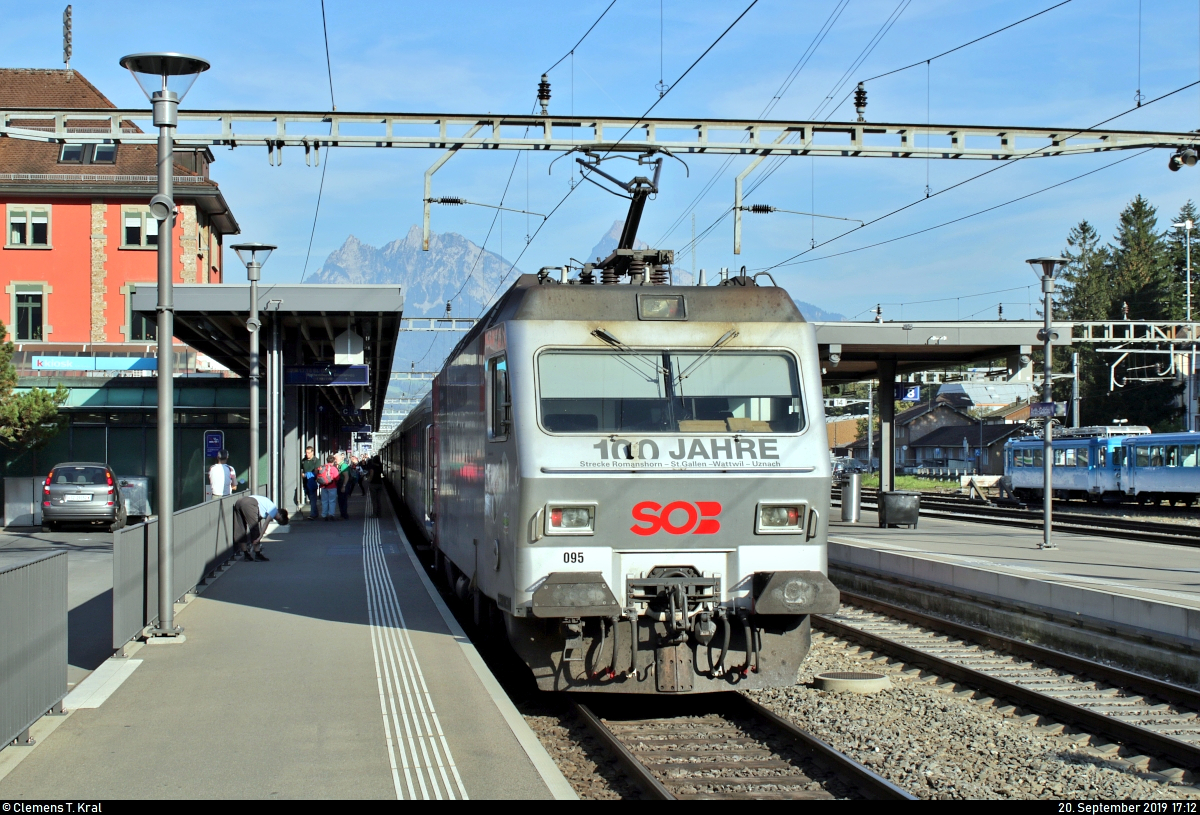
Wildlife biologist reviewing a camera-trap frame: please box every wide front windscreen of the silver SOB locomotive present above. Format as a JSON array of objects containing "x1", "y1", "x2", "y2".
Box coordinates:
[{"x1": 538, "y1": 350, "x2": 804, "y2": 433}]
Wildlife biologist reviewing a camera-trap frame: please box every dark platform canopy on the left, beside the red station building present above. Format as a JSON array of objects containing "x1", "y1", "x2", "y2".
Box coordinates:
[{"x1": 130, "y1": 283, "x2": 404, "y2": 427}]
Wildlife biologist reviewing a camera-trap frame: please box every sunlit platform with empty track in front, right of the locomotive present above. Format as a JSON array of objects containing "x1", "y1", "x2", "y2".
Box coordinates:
[{"x1": 829, "y1": 510, "x2": 1200, "y2": 684}]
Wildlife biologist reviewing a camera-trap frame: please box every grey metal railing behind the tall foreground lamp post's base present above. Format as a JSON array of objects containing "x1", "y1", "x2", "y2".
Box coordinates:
[{"x1": 113, "y1": 492, "x2": 246, "y2": 651}]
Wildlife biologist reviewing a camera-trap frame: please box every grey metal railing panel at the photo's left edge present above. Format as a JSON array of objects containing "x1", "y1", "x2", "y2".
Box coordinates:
[{"x1": 0, "y1": 551, "x2": 67, "y2": 749}]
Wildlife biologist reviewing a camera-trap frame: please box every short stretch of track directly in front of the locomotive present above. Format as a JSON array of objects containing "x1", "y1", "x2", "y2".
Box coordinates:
[{"x1": 574, "y1": 694, "x2": 916, "y2": 801}]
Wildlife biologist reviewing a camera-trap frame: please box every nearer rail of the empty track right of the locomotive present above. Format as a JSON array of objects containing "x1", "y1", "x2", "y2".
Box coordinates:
[{"x1": 814, "y1": 615, "x2": 1200, "y2": 769}]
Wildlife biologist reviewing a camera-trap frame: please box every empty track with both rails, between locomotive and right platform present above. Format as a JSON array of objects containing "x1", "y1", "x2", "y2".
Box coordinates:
[{"x1": 814, "y1": 592, "x2": 1200, "y2": 783}]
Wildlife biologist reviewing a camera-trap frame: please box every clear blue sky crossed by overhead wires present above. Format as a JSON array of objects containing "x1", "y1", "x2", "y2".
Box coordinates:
[{"x1": 0, "y1": 0, "x2": 1200, "y2": 319}]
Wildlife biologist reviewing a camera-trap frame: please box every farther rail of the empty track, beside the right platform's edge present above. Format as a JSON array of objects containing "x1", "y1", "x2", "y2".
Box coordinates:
[{"x1": 841, "y1": 589, "x2": 1200, "y2": 711}]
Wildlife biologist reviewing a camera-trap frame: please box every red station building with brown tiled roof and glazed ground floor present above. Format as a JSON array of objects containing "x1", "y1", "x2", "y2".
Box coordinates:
[{"x1": 0, "y1": 68, "x2": 250, "y2": 507}]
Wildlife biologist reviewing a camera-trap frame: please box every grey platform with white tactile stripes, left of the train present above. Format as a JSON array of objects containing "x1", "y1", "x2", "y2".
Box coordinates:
[{"x1": 0, "y1": 497, "x2": 575, "y2": 801}]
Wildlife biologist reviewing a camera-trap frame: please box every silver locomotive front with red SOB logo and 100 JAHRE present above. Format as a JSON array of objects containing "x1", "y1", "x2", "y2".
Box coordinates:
[{"x1": 468, "y1": 286, "x2": 838, "y2": 693}]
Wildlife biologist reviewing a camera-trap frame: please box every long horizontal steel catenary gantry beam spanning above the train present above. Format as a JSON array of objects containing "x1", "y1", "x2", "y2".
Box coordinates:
[{"x1": 0, "y1": 108, "x2": 1200, "y2": 161}]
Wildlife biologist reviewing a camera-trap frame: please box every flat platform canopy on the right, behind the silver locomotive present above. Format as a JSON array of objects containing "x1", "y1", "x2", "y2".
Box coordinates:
[{"x1": 812, "y1": 319, "x2": 1072, "y2": 385}]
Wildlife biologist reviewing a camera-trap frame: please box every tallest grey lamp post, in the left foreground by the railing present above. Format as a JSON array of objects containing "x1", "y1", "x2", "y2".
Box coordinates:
[{"x1": 120, "y1": 53, "x2": 209, "y2": 641}]
